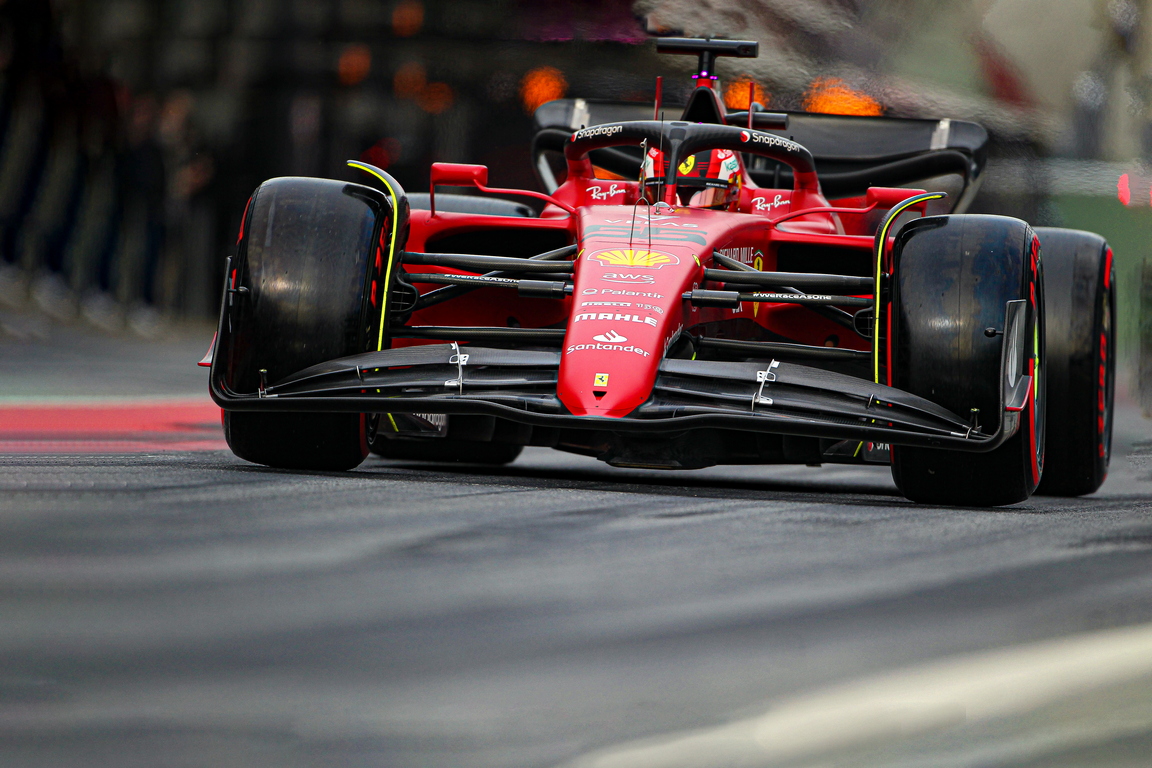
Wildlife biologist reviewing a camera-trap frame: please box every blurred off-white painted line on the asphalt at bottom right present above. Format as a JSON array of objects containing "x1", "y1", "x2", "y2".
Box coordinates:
[{"x1": 567, "y1": 624, "x2": 1152, "y2": 768}]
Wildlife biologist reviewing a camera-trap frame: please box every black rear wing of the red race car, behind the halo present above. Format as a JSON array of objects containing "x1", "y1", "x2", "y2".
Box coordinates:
[{"x1": 532, "y1": 99, "x2": 988, "y2": 213}]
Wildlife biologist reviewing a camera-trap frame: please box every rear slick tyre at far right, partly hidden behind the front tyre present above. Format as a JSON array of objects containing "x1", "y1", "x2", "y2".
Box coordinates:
[{"x1": 1036, "y1": 228, "x2": 1116, "y2": 496}]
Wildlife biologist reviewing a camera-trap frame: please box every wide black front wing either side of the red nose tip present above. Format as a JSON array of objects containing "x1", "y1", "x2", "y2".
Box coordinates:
[{"x1": 211, "y1": 302, "x2": 1031, "y2": 451}]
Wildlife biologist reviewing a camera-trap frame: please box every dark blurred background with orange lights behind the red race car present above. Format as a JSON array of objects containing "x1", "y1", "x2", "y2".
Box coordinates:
[{"x1": 0, "y1": 0, "x2": 1152, "y2": 391}]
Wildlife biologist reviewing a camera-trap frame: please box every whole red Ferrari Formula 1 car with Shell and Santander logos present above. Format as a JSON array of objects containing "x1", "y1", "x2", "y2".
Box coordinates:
[{"x1": 211, "y1": 38, "x2": 1115, "y2": 505}]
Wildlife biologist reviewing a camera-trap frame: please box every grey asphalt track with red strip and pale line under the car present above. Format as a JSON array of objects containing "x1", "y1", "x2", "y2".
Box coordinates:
[{"x1": 0, "y1": 329, "x2": 1152, "y2": 768}]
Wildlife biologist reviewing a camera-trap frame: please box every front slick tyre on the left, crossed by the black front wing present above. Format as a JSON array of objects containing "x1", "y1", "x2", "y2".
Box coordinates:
[{"x1": 223, "y1": 178, "x2": 387, "y2": 470}]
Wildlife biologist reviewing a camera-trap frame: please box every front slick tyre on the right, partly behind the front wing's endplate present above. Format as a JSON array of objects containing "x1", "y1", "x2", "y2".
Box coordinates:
[{"x1": 890, "y1": 215, "x2": 1046, "y2": 507}]
